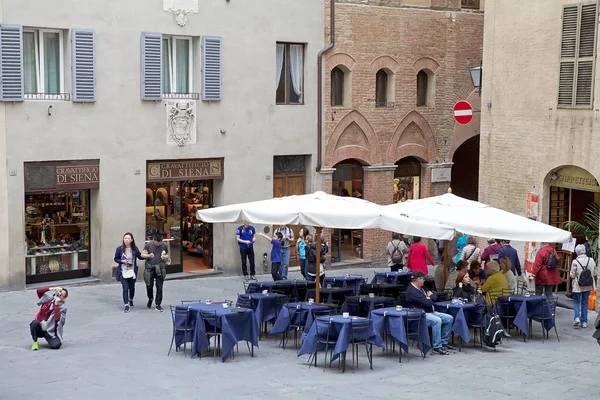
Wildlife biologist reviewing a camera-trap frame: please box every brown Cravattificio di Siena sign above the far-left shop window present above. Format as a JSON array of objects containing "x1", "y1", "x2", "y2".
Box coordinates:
[{"x1": 25, "y1": 160, "x2": 100, "y2": 193}]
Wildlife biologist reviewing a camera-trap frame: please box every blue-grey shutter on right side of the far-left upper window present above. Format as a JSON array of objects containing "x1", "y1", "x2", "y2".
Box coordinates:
[{"x1": 71, "y1": 29, "x2": 96, "y2": 103}]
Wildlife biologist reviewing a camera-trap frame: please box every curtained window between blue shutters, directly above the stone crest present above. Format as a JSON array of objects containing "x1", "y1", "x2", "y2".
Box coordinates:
[{"x1": 162, "y1": 36, "x2": 193, "y2": 94}]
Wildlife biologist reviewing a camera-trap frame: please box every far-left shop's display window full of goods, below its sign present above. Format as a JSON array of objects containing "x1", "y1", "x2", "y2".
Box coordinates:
[{"x1": 25, "y1": 190, "x2": 90, "y2": 283}]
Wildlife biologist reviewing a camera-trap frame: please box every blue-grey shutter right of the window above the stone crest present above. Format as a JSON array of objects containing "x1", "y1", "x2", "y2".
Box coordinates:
[{"x1": 202, "y1": 36, "x2": 222, "y2": 101}]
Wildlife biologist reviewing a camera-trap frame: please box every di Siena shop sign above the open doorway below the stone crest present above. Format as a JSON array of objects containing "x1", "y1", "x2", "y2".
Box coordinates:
[{"x1": 146, "y1": 158, "x2": 223, "y2": 182}]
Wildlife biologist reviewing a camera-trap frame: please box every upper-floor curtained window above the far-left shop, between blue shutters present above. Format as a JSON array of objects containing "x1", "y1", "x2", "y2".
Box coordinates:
[{"x1": 23, "y1": 29, "x2": 64, "y2": 99}]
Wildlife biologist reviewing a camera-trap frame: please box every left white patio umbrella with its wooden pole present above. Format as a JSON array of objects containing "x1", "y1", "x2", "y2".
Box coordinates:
[{"x1": 197, "y1": 192, "x2": 455, "y2": 301}]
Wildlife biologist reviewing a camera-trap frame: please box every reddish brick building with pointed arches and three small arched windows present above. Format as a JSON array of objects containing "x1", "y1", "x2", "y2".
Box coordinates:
[{"x1": 321, "y1": 0, "x2": 483, "y2": 266}]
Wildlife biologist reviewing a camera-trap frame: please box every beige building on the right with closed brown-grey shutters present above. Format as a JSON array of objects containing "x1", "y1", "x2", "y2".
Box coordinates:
[{"x1": 479, "y1": 0, "x2": 600, "y2": 268}]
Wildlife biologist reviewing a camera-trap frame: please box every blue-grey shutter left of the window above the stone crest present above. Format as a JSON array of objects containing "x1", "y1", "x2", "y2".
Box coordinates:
[{"x1": 141, "y1": 32, "x2": 162, "y2": 100}]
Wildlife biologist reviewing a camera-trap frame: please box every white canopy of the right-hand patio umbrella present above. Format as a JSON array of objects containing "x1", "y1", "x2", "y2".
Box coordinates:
[{"x1": 385, "y1": 193, "x2": 571, "y2": 243}]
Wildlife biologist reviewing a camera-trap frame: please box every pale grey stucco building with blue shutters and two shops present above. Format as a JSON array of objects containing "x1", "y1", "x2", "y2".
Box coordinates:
[{"x1": 0, "y1": 0, "x2": 324, "y2": 290}]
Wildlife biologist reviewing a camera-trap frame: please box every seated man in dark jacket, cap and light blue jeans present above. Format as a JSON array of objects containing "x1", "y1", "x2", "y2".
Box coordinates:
[{"x1": 406, "y1": 271, "x2": 456, "y2": 355}]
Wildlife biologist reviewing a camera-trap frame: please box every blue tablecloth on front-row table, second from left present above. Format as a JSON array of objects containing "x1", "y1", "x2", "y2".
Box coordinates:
[{"x1": 298, "y1": 315, "x2": 385, "y2": 360}]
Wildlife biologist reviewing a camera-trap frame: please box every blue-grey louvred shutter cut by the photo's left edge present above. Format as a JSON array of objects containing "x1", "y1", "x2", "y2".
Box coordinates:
[{"x1": 0, "y1": 25, "x2": 24, "y2": 101}]
